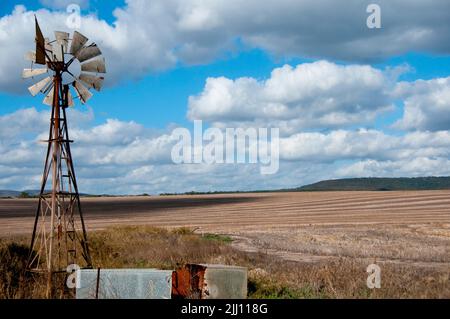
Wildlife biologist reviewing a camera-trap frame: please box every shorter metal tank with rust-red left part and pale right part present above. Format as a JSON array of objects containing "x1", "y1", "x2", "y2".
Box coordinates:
[{"x1": 172, "y1": 264, "x2": 247, "y2": 299}]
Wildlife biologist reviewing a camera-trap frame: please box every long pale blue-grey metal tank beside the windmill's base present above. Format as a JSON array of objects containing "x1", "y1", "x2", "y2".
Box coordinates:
[{"x1": 76, "y1": 269, "x2": 172, "y2": 299}]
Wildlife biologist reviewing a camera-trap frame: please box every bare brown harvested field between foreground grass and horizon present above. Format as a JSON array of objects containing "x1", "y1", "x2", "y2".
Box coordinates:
[{"x1": 0, "y1": 191, "x2": 450, "y2": 269}]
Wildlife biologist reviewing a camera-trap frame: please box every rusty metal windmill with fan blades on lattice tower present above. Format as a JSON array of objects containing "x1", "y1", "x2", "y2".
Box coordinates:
[{"x1": 23, "y1": 18, "x2": 106, "y2": 297}]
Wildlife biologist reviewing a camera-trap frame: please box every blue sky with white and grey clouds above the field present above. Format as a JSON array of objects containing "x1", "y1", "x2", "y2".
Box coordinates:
[{"x1": 0, "y1": 0, "x2": 450, "y2": 194}]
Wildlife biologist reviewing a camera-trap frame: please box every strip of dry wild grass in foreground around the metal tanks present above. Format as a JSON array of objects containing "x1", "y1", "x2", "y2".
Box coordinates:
[{"x1": 0, "y1": 226, "x2": 450, "y2": 298}]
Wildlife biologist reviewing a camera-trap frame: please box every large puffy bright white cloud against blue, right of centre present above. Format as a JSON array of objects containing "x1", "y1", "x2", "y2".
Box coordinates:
[{"x1": 188, "y1": 61, "x2": 395, "y2": 133}]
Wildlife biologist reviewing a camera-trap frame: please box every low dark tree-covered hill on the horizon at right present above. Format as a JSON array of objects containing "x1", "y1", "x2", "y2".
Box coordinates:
[{"x1": 291, "y1": 177, "x2": 450, "y2": 191}]
